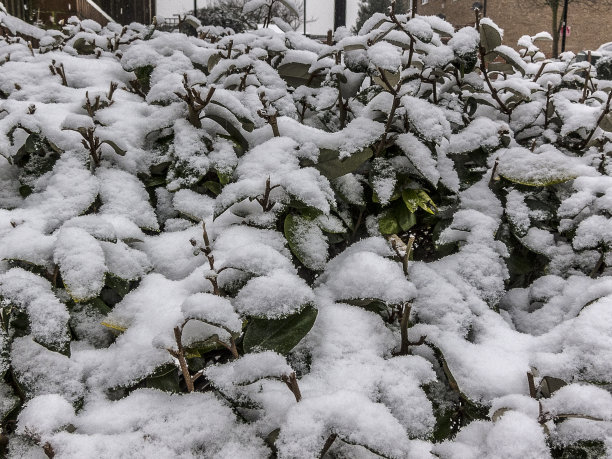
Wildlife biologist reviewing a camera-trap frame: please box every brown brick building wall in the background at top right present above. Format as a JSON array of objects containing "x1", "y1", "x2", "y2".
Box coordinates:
[{"x1": 416, "y1": 0, "x2": 612, "y2": 55}]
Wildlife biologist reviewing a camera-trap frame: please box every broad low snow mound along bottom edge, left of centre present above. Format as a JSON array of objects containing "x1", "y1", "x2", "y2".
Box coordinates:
[{"x1": 37, "y1": 389, "x2": 269, "y2": 459}]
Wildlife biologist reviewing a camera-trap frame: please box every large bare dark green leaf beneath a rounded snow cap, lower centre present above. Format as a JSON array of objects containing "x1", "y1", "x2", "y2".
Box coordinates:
[{"x1": 242, "y1": 305, "x2": 317, "y2": 354}]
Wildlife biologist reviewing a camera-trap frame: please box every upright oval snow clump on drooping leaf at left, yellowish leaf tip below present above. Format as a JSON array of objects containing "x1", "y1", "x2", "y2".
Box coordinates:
[{"x1": 53, "y1": 228, "x2": 107, "y2": 301}]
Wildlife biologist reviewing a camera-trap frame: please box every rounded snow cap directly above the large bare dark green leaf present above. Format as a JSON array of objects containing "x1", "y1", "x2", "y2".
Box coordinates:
[{"x1": 234, "y1": 270, "x2": 315, "y2": 319}]
